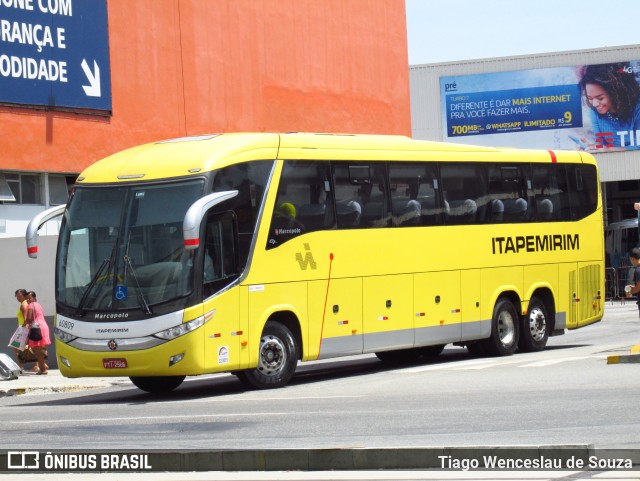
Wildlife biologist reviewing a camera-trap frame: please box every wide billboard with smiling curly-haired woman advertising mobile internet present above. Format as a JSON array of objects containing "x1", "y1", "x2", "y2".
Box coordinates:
[{"x1": 440, "y1": 61, "x2": 640, "y2": 152}]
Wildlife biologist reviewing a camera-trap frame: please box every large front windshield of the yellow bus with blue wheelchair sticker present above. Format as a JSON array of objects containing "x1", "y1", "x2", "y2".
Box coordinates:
[{"x1": 56, "y1": 179, "x2": 204, "y2": 320}]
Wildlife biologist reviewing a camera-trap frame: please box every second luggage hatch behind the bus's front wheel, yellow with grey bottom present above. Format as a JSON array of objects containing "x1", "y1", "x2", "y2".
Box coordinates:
[{"x1": 362, "y1": 274, "x2": 414, "y2": 352}]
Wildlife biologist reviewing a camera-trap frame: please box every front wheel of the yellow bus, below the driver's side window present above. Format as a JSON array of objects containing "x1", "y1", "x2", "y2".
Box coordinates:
[{"x1": 236, "y1": 322, "x2": 298, "y2": 389}]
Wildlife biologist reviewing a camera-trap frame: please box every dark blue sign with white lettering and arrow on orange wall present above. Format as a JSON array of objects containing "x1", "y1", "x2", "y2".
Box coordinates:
[{"x1": 0, "y1": 0, "x2": 111, "y2": 112}]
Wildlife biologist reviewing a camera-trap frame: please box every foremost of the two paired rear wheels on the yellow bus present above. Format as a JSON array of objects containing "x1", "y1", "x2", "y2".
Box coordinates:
[{"x1": 482, "y1": 297, "x2": 520, "y2": 356}]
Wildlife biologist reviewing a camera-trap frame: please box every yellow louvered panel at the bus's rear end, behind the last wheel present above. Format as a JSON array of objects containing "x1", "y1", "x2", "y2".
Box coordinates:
[{"x1": 560, "y1": 263, "x2": 604, "y2": 329}]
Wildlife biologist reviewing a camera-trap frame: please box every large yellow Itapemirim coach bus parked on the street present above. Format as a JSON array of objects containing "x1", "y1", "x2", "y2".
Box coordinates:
[{"x1": 27, "y1": 133, "x2": 604, "y2": 392}]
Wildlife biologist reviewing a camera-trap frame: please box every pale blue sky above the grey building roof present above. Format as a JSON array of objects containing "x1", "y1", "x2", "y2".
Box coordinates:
[{"x1": 406, "y1": 0, "x2": 640, "y2": 65}]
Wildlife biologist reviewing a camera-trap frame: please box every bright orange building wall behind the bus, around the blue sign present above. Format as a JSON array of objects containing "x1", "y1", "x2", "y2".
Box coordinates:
[{"x1": 0, "y1": 0, "x2": 411, "y2": 172}]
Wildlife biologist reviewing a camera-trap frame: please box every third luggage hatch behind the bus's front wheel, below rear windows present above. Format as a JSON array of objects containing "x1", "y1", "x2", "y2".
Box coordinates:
[{"x1": 413, "y1": 271, "x2": 461, "y2": 346}]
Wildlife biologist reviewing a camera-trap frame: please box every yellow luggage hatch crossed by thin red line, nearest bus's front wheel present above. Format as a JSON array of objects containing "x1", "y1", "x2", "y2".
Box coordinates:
[{"x1": 308, "y1": 277, "x2": 363, "y2": 359}]
